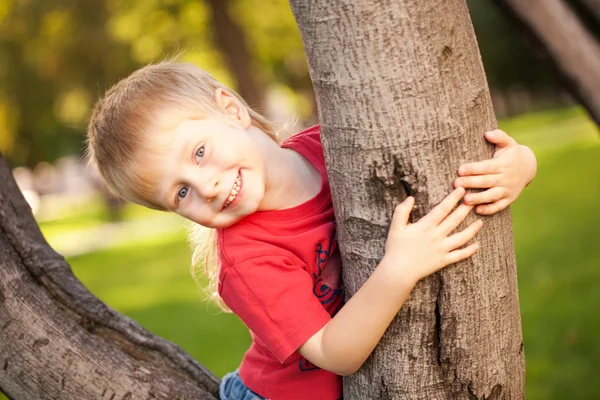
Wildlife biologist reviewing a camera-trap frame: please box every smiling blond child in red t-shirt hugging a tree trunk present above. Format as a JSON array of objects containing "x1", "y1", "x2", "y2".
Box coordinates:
[{"x1": 88, "y1": 62, "x2": 536, "y2": 400}]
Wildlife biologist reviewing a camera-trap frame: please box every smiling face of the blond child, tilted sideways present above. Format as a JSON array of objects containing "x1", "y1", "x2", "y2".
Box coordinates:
[{"x1": 141, "y1": 118, "x2": 266, "y2": 228}]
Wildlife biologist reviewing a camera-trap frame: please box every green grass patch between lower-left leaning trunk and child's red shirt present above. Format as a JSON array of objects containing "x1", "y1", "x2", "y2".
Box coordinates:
[{"x1": 69, "y1": 233, "x2": 250, "y2": 376}]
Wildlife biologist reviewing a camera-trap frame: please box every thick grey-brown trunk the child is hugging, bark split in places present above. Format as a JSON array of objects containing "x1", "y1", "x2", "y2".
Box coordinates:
[{"x1": 290, "y1": 0, "x2": 524, "y2": 400}]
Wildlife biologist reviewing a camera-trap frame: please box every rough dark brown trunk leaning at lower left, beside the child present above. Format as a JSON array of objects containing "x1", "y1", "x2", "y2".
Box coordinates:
[{"x1": 0, "y1": 155, "x2": 219, "y2": 400}]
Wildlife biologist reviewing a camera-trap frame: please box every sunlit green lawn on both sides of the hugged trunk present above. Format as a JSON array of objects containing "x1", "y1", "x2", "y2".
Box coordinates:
[{"x1": 0, "y1": 108, "x2": 600, "y2": 400}]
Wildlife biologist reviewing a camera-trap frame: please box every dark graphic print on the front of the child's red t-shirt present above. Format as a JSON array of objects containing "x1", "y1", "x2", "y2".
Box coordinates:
[{"x1": 298, "y1": 221, "x2": 343, "y2": 371}]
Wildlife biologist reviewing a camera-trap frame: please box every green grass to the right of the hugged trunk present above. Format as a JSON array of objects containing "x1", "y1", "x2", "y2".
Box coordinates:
[{"x1": 513, "y1": 143, "x2": 600, "y2": 399}]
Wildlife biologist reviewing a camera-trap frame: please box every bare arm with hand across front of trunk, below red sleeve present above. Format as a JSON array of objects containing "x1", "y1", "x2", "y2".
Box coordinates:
[{"x1": 298, "y1": 188, "x2": 483, "y2": 375}]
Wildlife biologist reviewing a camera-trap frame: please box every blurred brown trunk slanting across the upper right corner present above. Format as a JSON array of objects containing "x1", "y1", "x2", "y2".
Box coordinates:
[{"x1": 494, "y1": 0, "x2": 600, "y2": 126}]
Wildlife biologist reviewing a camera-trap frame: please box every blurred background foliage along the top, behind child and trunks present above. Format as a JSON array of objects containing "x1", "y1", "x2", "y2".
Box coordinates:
[{"x1": 0, "y1": 0, "x2": 572, "y2": 167}]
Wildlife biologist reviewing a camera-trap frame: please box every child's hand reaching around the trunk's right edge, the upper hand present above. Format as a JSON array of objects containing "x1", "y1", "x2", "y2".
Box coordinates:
[{"x1": 454, "y1": 129, "x2": 537, "y2": 215}]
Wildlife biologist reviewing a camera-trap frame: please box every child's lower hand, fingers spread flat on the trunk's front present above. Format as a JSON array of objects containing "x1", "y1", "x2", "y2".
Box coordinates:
[{"x1": 384, "y1": 188, "x2": 483, "y2": 284}]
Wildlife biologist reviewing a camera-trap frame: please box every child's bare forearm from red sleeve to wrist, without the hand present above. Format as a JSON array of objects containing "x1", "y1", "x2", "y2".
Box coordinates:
[{"x1": 308, "y1": 259, "x2": 414, "y2": 375}]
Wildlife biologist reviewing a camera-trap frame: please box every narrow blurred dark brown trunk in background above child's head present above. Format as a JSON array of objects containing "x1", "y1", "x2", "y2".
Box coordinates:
[{"x1": 208, "y1": 0, "x2": 264, "y2": 109}]
